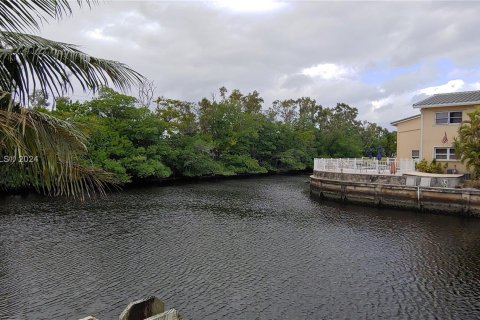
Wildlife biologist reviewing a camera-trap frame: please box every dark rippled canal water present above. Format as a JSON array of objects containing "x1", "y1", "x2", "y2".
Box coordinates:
[{"x1": 0, "y1": 176, "x2": 480, "y2": 319}]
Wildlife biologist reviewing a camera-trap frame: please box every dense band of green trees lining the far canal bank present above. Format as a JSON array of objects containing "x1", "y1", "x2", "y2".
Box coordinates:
[{"x1": 30, "y1": 88, "x2": 396, "y2": 183}]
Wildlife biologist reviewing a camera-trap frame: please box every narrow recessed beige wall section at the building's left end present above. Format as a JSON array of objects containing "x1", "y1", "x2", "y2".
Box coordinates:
[{"x1": 396, "y1": 118, "x2": 420, "y2": 159}]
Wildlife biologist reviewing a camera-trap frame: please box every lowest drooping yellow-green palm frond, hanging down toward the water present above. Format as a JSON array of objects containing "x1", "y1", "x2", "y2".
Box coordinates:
[{"x1": 0, "y1": 106, "x2": 115, "y2": 199}]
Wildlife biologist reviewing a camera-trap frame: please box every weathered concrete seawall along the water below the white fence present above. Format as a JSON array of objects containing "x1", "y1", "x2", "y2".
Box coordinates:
[{"x1": 310, "y1": 171, "x2": 480, "y2": 218}]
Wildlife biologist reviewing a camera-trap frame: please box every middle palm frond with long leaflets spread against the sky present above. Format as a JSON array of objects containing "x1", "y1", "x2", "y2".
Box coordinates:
[{"x1": 0, "y1": 32, "x2": 144, "y2": 104}]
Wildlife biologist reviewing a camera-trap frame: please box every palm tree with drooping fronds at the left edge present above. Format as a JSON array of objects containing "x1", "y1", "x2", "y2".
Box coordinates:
[{"x1": 0, "y1": 0, "x2": 143, "y2": 199}]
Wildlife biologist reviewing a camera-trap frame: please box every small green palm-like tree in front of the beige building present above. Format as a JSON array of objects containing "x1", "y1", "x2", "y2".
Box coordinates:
[{"x1": 453, "y1": 109, "x2": 480, "y2": 178}]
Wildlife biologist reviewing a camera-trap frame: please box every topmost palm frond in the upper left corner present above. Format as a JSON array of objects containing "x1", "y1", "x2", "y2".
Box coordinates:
[{"x1": 0, "y1": 0, "x2": 97, "y2": 31}]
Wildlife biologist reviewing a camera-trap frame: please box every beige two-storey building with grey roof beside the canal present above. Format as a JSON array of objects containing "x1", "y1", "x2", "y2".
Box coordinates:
[{"x1": 391, "y1": 91, "x2": 480, "y2": 173}]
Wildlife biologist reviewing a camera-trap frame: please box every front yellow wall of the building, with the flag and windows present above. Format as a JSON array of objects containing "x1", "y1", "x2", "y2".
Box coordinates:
[{"x1": 420, "y1": 106, "x2": 476, "y2": 173}]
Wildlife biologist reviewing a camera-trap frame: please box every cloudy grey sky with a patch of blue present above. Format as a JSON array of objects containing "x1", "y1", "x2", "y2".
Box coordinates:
[{"x1": 40, "y1": 0, "x2": 480, "y2": 128}]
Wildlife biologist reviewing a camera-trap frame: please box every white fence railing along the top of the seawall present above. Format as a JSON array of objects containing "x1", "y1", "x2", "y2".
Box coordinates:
[{"x1": 313, "y1": 158, "x2": 418, "y2": 175}]
